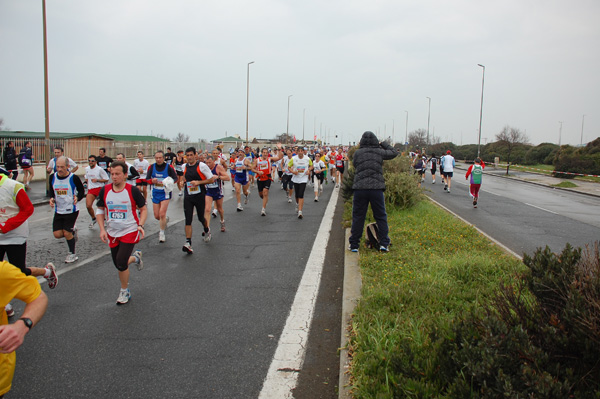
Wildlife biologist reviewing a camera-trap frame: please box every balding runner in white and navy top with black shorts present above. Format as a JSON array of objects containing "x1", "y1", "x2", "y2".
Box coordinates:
[{"x1": 50, "y1": 156, "x2": 85, "y2": 263}]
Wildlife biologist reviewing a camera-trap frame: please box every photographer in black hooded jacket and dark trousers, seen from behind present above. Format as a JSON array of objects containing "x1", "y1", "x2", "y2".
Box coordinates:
[{"x1": 349, "y1": 132, "x2": 398, "y2": 252}]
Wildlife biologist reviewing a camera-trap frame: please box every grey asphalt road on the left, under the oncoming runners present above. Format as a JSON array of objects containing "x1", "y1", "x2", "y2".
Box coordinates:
[{"x1": 7, "y1": 180, "x2": 343, "y2": 399}]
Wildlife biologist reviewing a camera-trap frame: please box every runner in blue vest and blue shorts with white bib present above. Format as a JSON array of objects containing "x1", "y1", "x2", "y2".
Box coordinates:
[{"x1": 146, "y1": 151, "x2": 178, "y2": 242}]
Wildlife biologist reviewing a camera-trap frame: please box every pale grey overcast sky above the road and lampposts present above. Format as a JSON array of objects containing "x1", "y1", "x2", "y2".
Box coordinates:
[{"x1": 0, "y1": 0, "x2": 600, "y2": 145}]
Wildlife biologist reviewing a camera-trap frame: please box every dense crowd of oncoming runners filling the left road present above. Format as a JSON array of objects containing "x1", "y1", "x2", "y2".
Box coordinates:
[{"x1": 0, "y1": 144, "x2": 348, "y2": 310}]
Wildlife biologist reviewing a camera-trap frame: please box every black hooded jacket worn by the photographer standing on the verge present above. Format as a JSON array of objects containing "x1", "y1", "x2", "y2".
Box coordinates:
[{"x1": 352, "y1": 132, "x2": 398, "y2": 190}]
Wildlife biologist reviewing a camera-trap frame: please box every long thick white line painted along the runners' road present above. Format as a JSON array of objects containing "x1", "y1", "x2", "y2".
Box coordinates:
[{"x1": 258, "y1": 189, "x2": 339, "y2": 399}]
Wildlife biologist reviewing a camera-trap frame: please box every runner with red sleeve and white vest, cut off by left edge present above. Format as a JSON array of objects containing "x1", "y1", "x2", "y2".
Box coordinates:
[{"x1": 0, "y1": 175, "x2": 58, "y2": 317}]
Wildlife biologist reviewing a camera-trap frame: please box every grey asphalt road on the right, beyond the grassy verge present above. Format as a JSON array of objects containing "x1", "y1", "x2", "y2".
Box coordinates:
[{"x1": 424, "y1": 170, "x2": 600, "y2": 255}]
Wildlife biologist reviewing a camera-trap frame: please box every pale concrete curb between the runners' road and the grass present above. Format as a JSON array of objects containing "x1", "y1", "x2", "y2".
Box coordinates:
[{"x1": 338, "y1": 228, "x2": 362, "y2": 399}]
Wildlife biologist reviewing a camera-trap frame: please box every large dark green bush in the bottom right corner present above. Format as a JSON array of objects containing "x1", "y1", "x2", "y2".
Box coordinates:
[{"x1": 437, "y1": 243, "x2": 600, "y2": 398}]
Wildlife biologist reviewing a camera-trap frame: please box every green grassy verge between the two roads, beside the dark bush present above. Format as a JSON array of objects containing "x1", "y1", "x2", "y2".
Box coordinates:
[{"x1": 350, "y1": 201, "x2": 524, "y2": 398}]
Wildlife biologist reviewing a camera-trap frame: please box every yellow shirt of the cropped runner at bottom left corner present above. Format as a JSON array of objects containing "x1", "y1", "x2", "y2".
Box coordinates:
[{"x1": 0, "y1": 262, "x2": 42, "y2": 396}]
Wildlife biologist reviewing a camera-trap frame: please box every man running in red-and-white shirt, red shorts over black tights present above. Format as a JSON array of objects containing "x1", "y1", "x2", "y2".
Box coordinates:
[{"x1": 96, "y1": 161, "x2": 148, "y2": 305}]
